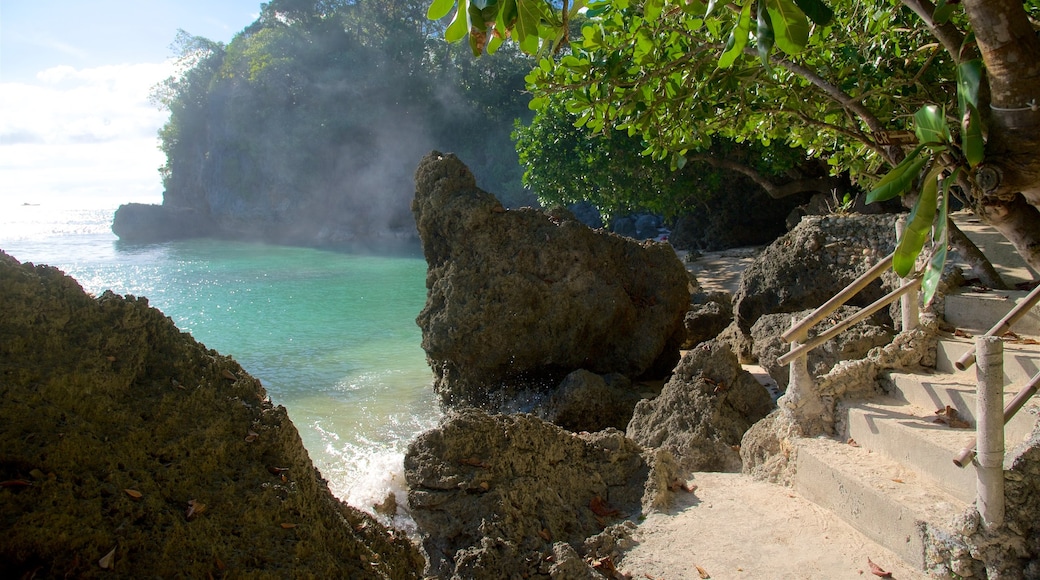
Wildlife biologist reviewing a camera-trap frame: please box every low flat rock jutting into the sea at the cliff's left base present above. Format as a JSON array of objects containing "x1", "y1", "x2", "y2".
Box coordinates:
[{"x1": 112, "y1": 204, "x2": 214, "y2": 243}]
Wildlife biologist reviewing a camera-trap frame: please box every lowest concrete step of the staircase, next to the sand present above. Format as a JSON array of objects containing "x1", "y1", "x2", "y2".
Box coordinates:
[{"x1": 795, "y1": 439, "x2": 968, "y2": 570}]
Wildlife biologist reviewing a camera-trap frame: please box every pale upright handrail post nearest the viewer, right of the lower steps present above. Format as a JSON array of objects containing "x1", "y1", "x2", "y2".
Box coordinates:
[{"x1": 976, "y1": 336, "x2": 1004, "y2": 528}]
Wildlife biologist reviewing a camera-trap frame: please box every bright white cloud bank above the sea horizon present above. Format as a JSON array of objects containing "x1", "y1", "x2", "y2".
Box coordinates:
[{"x1": 0, "y1": 62, "x2": 173, "y2": 207}]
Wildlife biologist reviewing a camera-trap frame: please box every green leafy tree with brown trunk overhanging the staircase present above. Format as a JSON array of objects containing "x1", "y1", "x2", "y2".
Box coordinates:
[{"x1": 428, "y1": 0, "x2": 1040, "y2": 293}]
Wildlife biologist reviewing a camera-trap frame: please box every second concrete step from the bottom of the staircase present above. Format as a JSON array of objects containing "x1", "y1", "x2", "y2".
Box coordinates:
[{"x1": 841, "y1": 397, "x2": 977, "y2": 503}]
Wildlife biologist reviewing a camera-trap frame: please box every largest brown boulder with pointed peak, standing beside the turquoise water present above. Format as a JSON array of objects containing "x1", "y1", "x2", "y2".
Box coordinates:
[{"x1": 412, "y1": 152, "x2": 690, "y2": 404}]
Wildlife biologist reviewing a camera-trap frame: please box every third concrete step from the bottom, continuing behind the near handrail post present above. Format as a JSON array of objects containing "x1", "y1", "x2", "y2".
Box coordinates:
[{"x1": 886, "y1": 367, "x2": 1040, "y2": 444}]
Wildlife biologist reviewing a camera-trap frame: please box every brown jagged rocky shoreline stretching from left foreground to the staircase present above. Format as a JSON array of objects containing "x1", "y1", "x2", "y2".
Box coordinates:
[{"x1": 0, "y1": 152, "x2": 1035, "y2": 580}]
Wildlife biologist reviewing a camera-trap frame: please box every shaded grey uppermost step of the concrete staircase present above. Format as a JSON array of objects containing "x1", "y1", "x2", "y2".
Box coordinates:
[{"x1": 943, "y1": 290, "x2": 1040, "y2": 336}]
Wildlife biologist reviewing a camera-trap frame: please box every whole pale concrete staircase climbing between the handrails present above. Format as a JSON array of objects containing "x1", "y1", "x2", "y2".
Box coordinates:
[{"x1": 795, "y1": 217, "x2": 1040, "y2": 570}]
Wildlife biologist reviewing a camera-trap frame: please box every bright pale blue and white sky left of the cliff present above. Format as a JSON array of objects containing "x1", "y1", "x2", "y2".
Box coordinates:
[{"x1": 0, "y1": 0, "x2": 261, "y2": 208}]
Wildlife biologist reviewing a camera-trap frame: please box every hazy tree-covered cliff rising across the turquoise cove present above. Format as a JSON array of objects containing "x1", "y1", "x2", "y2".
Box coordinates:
[{"x1": 154, "y1": 0, "x2": 531, "y2": 241}]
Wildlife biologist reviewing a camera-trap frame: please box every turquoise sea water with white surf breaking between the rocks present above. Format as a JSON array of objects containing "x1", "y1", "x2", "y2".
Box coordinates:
[{"x1": 0, "y1": 205, "x2": 442, "y2": 528}]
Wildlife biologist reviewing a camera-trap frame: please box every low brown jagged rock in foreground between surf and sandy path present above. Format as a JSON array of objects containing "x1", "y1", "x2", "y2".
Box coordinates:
[{"x1": 405, "y1": 408, "x2": 673, "y2": 578}]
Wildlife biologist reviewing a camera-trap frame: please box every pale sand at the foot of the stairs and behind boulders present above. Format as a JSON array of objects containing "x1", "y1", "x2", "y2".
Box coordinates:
[{"x1": 618, "y1": 248, "x2": 928, "y2": 580}]
